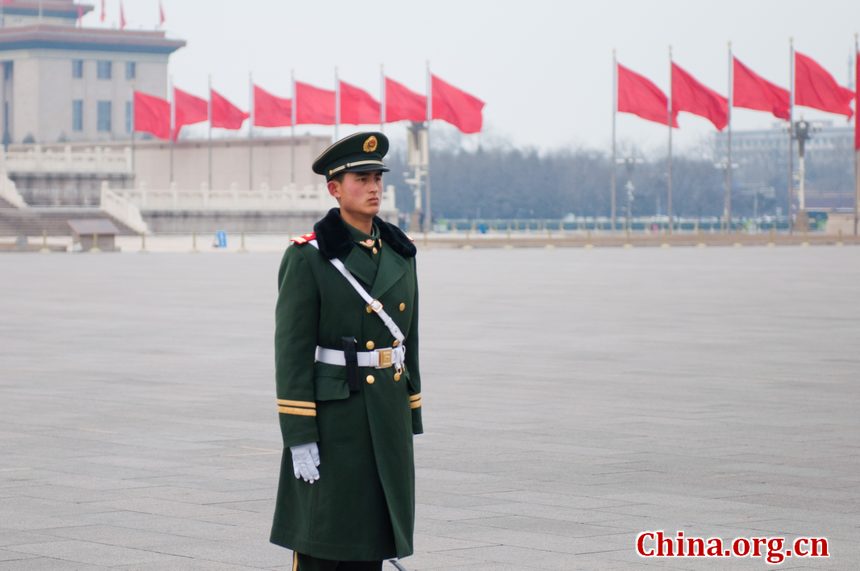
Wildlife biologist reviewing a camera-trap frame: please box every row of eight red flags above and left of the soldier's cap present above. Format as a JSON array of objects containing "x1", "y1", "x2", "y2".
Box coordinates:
[{"x1": 134, "y1": 75, "x2": 484, "y2": 139}]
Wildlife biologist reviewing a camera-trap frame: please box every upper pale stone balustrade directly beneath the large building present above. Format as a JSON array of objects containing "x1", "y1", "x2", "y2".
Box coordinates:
[{"x1": 6, "y1": 145, "x2": 134, "y2": 175}]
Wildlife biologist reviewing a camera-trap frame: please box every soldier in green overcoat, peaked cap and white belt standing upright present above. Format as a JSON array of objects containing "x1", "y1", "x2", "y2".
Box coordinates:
[{"x1": 271, "y1": 132, "x2": 423, "y2": 571}]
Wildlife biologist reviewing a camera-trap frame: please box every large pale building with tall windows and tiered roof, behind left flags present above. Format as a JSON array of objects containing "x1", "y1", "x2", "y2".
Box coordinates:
[{"x1": 0, "y1": 0, "x2": 185, "y2": 145}]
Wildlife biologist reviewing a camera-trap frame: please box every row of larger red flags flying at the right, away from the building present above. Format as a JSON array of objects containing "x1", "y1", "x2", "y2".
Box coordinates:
[{"x1": 618, "y1": 52, "x2": 860, "y2": 143}]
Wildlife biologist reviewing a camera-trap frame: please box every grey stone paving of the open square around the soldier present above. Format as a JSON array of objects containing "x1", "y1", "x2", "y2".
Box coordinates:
[{"x1": 0, "y1": 246, "x2": 860, "y2": 571}]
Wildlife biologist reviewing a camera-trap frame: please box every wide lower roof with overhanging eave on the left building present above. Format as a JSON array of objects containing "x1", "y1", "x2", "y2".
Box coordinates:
[{"x1": 0, "y1": 24, "x2": 185, "y2": 54}]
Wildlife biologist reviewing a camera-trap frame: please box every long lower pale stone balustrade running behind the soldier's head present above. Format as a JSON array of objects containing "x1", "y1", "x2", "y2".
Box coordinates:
[{"x1": 116, "y1": 185, "x2": 395, "y2": 212}]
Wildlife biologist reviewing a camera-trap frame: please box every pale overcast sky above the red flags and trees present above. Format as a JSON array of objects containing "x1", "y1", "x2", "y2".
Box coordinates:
[{"x1": 85, "y1": 0, "x2": 860, "y2": 152}]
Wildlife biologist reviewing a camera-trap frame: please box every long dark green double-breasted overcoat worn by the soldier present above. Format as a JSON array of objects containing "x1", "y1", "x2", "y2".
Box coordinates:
[{"x1": 271, "y1": 209, "x2": 422, "y2": 561}]
